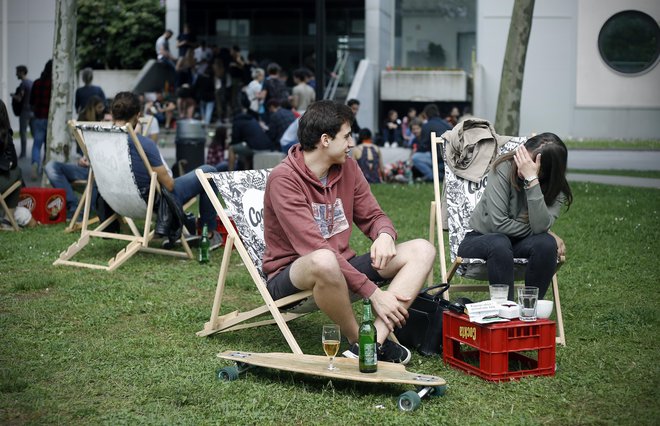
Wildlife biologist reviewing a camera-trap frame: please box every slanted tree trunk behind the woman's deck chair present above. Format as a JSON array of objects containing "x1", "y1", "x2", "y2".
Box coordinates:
[{"x1": 495, "y1": 0, "x2": 534, "y2": 136}]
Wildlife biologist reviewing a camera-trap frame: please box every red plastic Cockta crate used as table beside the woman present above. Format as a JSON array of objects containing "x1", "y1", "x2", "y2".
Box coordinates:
[{"x1": 442, "y1": 312, "x2": 556, "y2": 381}]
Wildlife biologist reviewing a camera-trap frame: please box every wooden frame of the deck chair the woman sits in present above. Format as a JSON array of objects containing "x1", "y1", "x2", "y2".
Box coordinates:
[{"x1": 429, "y1": 132, "x2": 566, "y2": 346}]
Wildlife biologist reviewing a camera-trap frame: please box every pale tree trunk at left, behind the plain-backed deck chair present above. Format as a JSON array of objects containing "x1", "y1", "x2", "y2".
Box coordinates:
[{"x1": 46, "y1": 0, "x2": 78, "y2": 169}]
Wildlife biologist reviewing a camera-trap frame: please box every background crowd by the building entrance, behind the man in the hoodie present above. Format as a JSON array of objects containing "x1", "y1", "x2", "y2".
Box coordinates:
[{"x1": 151, "y1": 26, "x2": 474, "y2": 182}]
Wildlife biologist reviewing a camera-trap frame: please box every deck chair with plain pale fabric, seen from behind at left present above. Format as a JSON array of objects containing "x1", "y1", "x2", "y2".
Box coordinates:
[{"x1": 53, "y1": 121, "x2": 193, "y2": 271}]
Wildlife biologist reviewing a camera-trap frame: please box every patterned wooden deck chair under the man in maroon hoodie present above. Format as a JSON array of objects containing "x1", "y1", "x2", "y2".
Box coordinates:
[{"x1": 195, "y1": 169, "x2": 330, "y2": 354}]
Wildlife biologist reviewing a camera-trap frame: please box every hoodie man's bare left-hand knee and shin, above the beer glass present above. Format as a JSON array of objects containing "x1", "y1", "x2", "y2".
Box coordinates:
[{"x1": 289, "y1": 249, "x2": 358, "y2": 343}]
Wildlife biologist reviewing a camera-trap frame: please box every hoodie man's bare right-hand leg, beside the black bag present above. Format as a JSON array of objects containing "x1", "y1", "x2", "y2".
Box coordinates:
[{"x1": 374, "y1": 239, "x2": 435, "y2": 343}]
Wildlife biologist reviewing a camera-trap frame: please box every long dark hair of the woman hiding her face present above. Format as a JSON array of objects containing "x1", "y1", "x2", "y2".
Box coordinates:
[{"x1": 493, "y1": 133, "x2": 573, "y2": 209}]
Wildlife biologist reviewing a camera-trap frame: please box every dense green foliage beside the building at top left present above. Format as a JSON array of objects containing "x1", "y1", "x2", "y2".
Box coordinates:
[{"x1": 76, "y1": 0, "x2": 165, "y2": 69}]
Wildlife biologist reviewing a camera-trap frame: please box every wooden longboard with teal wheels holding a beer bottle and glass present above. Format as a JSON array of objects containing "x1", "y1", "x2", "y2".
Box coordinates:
[{"x1": 217, "y1": 351, "x2": 447, "y2": 411}]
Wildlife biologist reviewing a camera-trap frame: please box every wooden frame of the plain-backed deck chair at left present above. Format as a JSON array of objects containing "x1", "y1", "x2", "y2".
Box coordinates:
[{"x1": 53, "y1": 120, "x2": 193, "y2": 271}]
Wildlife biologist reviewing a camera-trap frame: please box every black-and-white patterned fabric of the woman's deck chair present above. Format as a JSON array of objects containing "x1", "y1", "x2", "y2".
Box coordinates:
[{"x1": 442, "y1": 137, "x2": 527, "y2": 280}]
